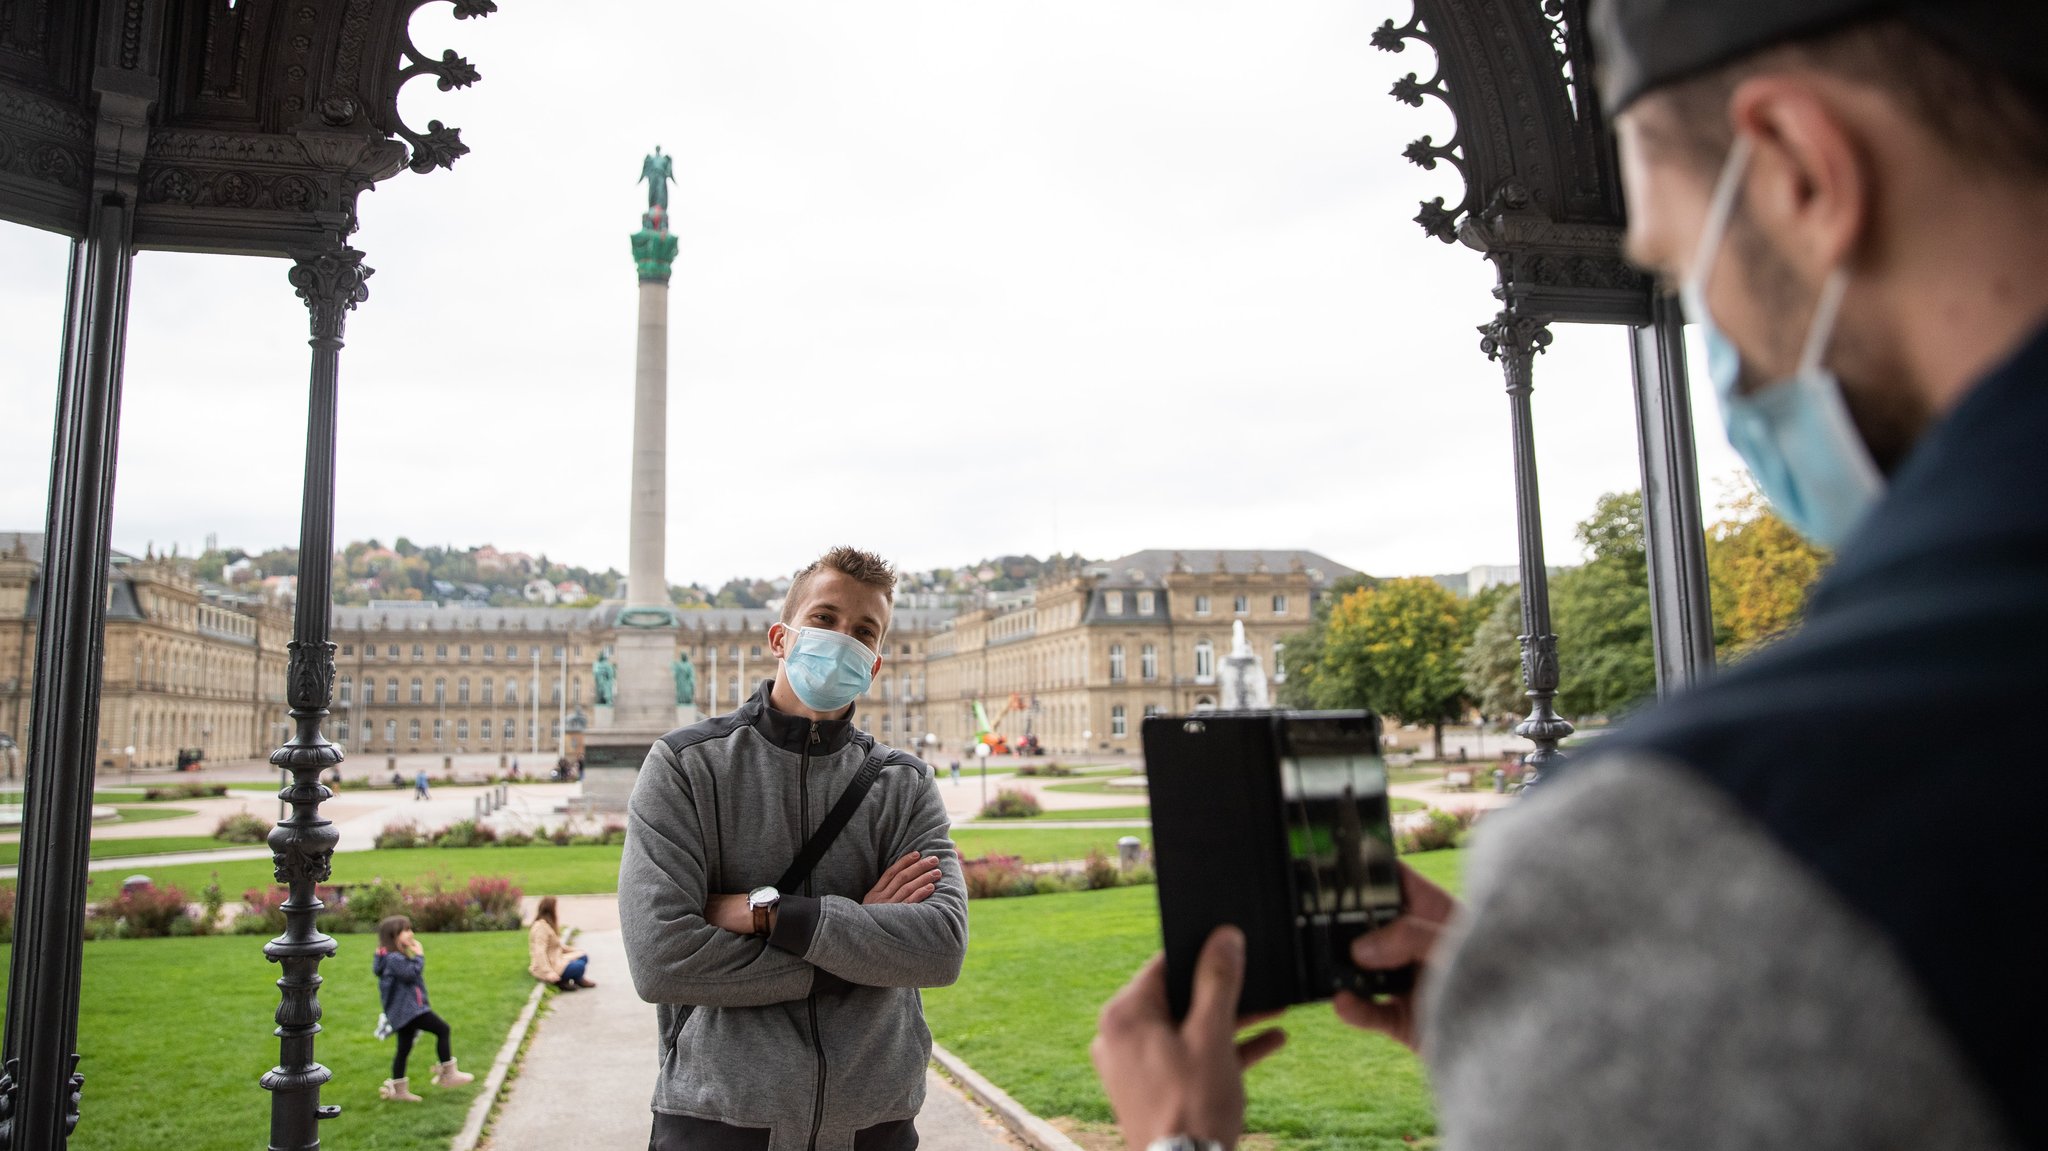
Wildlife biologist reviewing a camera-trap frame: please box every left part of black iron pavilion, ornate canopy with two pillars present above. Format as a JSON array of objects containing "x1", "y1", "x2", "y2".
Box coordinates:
[{"x1": 0, "y1": 0, "x2": 498, "y2": 1151}]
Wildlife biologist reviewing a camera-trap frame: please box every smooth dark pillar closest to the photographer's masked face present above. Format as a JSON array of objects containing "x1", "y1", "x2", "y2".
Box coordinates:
[{"x1": 1628, "y1": 295, "x2": 1714, "y2": 696}]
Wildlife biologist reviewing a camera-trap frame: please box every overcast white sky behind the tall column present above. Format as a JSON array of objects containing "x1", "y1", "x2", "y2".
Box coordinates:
[{"x1": 0, "y1": 0, "x2": 1739, "y2": 584}]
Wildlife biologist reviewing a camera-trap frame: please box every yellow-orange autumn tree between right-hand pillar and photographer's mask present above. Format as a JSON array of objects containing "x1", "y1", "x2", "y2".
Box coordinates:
[{"x1": 1706, "y1": 492, "x2": 1831, "y2": 659}]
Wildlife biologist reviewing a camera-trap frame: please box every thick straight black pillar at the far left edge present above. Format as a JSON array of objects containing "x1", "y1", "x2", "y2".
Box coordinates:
[{"x1": 0, "y1": 193, "x2": 135, "y2": 1151}]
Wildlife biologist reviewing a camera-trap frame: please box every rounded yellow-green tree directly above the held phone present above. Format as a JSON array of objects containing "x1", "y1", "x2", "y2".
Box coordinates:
[{"x1": 1309, "y1": 576, "x2": 1475, "y2": 760}]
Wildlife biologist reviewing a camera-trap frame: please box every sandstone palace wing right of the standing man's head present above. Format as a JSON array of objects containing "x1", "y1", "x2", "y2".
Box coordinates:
[{"x1": 926, "y1": 549, "x2": 1356, "y2": 756}]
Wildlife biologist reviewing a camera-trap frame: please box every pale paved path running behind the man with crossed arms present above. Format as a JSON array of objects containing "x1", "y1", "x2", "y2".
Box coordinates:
[{"x1": 481, "y1": 895, "x2": 1020, "y2": 1151}]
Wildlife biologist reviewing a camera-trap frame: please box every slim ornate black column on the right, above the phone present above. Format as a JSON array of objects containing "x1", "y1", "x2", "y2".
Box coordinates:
[{"x1": 1479, "y1": 309, "x2": 1571, "y2": 782}]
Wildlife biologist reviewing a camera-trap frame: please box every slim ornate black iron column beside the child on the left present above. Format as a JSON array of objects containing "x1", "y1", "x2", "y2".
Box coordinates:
[{"x1": 262, "y1": 246, "x2": 371, "y2": 1151}]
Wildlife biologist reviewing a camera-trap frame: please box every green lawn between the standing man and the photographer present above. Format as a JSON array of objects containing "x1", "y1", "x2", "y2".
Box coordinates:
[{"x1": 924, "y1": 852, "x2": 1458, "y2": 1151}]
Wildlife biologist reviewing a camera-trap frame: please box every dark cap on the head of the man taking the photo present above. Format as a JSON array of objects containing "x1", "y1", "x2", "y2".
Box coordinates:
[{"x1": 1587, "y1": 0, "x2": 2048, "y2": 115}]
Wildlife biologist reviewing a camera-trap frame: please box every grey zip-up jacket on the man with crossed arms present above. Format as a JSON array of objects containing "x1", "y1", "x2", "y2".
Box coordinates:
[{"x1": 618, "y1": 680, "x2": 967, "y2": 1151}]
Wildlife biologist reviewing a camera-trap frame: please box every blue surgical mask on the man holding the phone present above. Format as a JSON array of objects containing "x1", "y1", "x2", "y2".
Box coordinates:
[{"x1": 1679, "y1": 135, "x2": 1884, "y2": 547}]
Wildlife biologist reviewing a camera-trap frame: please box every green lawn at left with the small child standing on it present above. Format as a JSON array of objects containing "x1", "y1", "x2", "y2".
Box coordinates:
[{"x1": 0, "y1": 932, "x2": 532, "y2": 1151}]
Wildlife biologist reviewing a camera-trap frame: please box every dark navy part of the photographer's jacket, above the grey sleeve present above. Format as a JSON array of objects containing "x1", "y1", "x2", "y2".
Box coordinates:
[{"x1": 1602, "y1": 317, "x2": 2048, "y2": 1147}]
